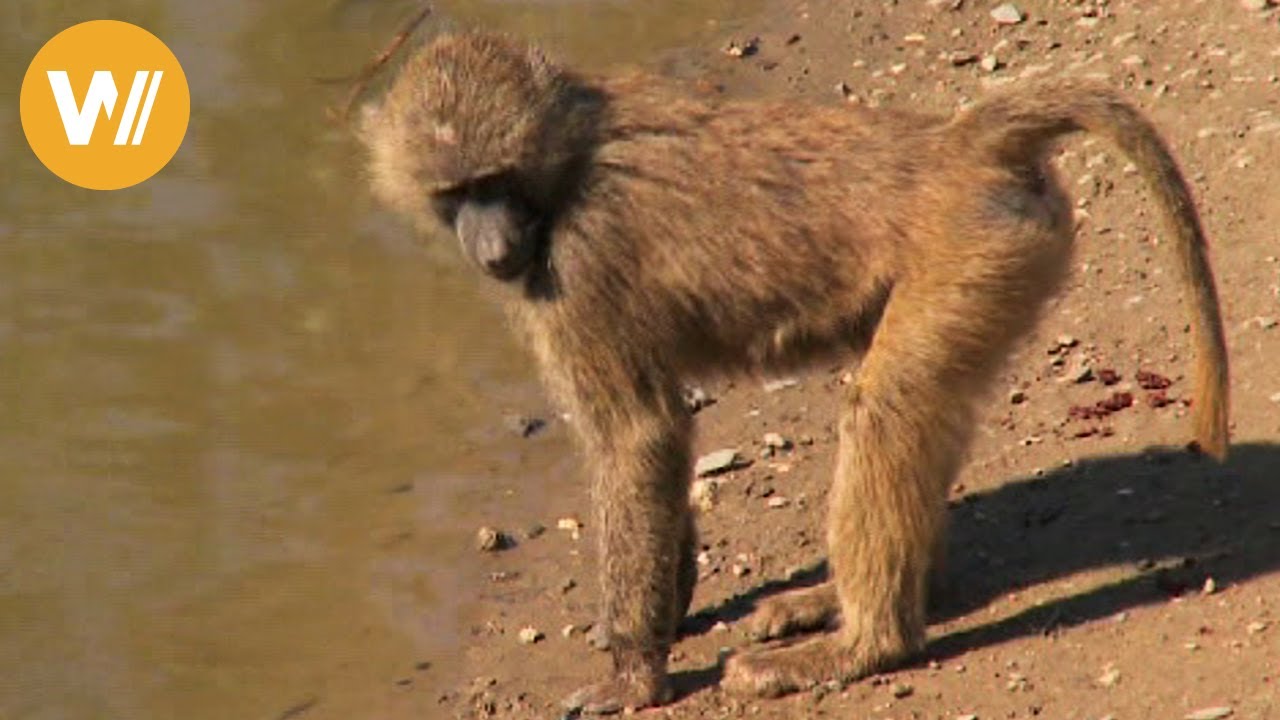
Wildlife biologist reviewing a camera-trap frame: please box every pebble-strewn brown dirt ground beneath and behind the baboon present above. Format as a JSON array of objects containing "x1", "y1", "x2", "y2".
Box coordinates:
[{"x1": 416, "y1": 0, "x2": 1280, "y2": 720}]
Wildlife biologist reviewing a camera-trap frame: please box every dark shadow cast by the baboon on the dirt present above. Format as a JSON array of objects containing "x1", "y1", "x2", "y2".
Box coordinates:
[{"x1": 677, "y1": 443, "x2": 1280, "y2": 692}]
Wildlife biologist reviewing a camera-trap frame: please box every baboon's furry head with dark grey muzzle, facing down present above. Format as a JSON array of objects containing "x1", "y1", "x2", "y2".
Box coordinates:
[{"x1": 360, "y1": 33, "x2": 599, "y2": 281}]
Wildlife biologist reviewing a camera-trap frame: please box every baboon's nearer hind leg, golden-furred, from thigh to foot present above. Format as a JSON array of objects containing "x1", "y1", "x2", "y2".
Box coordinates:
[{"x1": 724, "y1": 235, "x2": 1066, "y2": 696}]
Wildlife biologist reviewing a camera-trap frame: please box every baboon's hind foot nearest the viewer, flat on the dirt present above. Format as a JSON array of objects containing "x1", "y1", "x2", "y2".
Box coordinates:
[{"x1": 721, "y1": 638, "x2": 852, "y2": 697}]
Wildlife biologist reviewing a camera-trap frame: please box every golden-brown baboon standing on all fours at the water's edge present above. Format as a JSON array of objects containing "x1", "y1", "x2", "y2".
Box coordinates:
[{"x1": 361, "y1": 32, "x2": 1228, "y2": 712}]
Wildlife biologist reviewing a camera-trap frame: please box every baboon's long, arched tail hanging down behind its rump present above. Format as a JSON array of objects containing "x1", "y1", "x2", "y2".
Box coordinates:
[{"x1": 951, "y1": 79, "x2": 1229, "y2": 460}]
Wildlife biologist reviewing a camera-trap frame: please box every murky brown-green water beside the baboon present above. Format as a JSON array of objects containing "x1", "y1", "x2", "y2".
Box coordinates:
[{"x1": 0, "y1": 0, "x2": 745, "y2": 720}]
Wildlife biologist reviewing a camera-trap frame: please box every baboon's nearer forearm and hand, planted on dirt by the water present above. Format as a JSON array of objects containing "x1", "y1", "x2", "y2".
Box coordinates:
[{"x1": 566, "y1": 384, "x2": 695, "y2": 714}]
